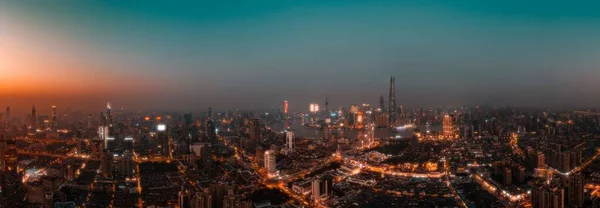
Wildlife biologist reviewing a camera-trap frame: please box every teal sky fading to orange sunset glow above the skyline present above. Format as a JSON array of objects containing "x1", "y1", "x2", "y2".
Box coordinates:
[{"x1": 0, "y1": 0, "x2": 600, "y2": 112}]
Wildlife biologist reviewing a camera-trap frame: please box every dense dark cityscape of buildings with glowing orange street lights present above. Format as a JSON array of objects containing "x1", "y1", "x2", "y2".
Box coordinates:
[{"x1": 0, "y1": 77, "x2": 600, "y2": 208}]
